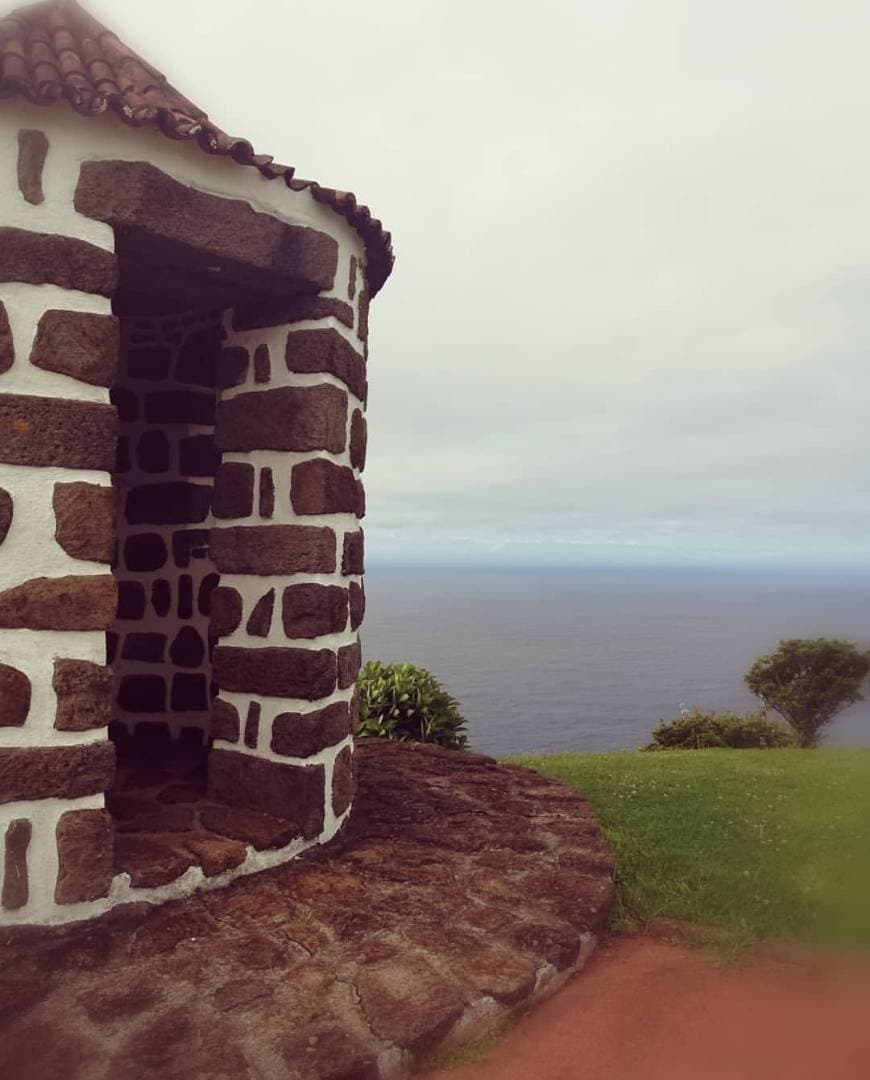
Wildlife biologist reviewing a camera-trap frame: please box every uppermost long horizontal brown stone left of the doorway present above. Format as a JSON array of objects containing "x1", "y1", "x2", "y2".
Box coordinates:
[{"x1": 0, "y1": 228, "x2": 118, "y2": 297}]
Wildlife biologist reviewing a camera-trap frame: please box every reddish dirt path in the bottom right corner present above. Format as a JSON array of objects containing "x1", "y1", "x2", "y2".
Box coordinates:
[{"x1": 425, "y1": 936, "x2": 870, "y2": 1080}]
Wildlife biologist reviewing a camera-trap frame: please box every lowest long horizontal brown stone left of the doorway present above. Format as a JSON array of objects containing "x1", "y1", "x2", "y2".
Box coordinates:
[{"x1": 0, "y1": 742, "x2": 114, "y2": 802}]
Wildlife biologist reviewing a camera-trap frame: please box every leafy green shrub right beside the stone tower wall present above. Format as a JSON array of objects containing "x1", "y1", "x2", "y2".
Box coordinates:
[{"x1": 356, "y1": 660, "x2": 468, "y2": 750}]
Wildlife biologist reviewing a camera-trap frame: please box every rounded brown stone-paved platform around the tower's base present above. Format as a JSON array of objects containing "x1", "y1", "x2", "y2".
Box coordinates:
[{"x1": 0, "y1": 741, "x2": 613, "y2": 1080}]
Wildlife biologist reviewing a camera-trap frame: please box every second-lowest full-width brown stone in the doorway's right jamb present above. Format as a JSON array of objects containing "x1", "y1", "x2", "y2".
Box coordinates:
[{"x1": 213, "y1": 645, "x2": 336, "y2": 701}]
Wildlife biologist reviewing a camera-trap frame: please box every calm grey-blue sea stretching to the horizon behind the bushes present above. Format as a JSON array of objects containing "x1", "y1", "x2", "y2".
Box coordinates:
[{"x1": 363, "y1": 565, "x2": 870, "y2": 755}]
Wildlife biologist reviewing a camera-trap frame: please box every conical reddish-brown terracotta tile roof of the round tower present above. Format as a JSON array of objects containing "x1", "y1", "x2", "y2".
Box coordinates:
[{"x1": 0, "y1": 0, "x2": 393, "y2": 295}]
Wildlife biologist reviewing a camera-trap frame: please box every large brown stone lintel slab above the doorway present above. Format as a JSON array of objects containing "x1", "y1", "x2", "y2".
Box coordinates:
[{"x1": 74, "y1": 161, "x2": 338, "y2": 293}]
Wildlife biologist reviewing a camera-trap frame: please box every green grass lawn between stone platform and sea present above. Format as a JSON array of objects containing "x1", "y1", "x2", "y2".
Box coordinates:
[{"x1": 513, "y1": 750, "x2": 870, "y2": 947}]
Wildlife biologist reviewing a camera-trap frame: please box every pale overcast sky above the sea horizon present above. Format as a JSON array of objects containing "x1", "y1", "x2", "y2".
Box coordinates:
[{"x1": 85, "y1": 0, "x2": 870, "y2": 565}]
